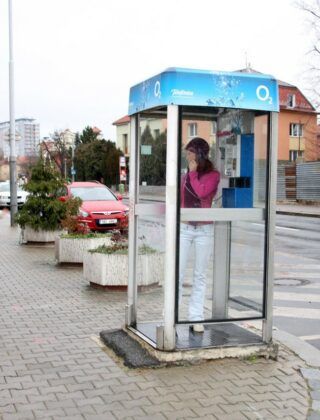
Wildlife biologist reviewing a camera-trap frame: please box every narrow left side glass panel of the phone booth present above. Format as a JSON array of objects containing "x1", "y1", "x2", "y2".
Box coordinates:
[{"x1": 137, "y1": 110, "x2": 167, "y2": 341}]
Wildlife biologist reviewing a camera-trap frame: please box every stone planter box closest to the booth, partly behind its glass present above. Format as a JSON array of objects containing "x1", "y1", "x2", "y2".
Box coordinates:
[{"x1": 83, "y1": 252, "x2": 164, "y2": 287}]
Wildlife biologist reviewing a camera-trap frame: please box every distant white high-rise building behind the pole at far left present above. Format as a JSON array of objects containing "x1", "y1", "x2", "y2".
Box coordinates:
[{"x1": 0, "y1": 118, "x2": 40, "y2": 158}]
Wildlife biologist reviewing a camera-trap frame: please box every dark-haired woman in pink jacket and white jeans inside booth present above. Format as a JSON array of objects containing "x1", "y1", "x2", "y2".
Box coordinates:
[{"x1": 179, "y1": 137, "x2": 220, "y2": 333}]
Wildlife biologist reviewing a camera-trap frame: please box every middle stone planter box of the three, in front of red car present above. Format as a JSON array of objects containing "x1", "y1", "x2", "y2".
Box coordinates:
[{"x1": 55, "y1": 235, "x2": 111, "y2": 264}]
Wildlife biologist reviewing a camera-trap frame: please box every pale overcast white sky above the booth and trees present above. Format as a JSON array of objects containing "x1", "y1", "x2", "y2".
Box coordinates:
[{"x1": 0, "y1": 0, "x2": 312, "y2": 141}]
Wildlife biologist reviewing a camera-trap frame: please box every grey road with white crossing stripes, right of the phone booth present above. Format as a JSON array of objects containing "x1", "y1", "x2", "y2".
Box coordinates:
[{"x1": 274, "y1": 215, "x2": 320, "y2": 349}]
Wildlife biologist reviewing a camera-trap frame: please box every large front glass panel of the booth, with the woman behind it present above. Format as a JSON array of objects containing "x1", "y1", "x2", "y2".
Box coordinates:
[{"x1": 177, "y1": 107, "x2": 268, "y2": 323}]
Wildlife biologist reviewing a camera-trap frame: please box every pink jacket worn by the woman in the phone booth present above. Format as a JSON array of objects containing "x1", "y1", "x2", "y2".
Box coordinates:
[{"x1": 181, "y1": 171, "x2": 220, "y2": 208}]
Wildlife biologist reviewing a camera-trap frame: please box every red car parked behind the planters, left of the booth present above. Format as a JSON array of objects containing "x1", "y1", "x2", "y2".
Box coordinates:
[{"x1": 60, "y1": 182, "x2": 129, "y2": 231}]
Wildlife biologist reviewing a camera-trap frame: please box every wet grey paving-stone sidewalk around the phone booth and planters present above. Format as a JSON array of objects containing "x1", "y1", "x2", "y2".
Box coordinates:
[{"x1": 0, "y1": 216, "x2": 319, "y2": 420}]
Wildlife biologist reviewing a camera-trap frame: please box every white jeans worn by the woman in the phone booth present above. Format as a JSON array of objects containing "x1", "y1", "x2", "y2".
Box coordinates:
[{"x1": 179, "y1": 223, "x2": 213, "y2": 321}]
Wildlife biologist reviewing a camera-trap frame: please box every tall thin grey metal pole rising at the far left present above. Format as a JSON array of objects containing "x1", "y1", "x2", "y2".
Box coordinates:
[{"x1": 8, "y1": 0, "x2": 18, "y2": 226}]
